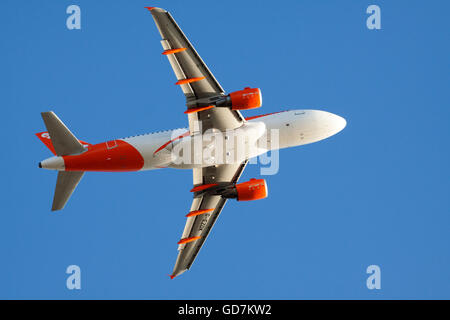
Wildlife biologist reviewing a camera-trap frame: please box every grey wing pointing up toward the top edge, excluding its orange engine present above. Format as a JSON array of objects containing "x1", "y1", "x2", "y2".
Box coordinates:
[{"x1": 147, "y1": 7, "x2": 245, "y2": 135}]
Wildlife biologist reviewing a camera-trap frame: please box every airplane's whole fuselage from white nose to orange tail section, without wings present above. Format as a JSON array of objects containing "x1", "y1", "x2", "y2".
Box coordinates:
[{"x1": 41, "y1": 110, "x2": 346, "y2": 172}]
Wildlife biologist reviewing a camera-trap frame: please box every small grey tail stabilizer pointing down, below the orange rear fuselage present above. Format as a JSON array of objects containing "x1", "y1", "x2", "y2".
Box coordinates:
[{"x1": 52, "y1": 171, "x2": 84, "y2": 211}]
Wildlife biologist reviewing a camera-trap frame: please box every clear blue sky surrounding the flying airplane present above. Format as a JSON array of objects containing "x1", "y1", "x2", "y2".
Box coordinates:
[{"x1": 0, "y1": 0, "x2": 450, "y2": 299}]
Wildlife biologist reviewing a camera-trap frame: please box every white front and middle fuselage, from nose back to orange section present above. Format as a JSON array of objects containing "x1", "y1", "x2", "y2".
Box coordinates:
[{"x1": 121, "y1": 110, "x2": 346, "y2": 170}]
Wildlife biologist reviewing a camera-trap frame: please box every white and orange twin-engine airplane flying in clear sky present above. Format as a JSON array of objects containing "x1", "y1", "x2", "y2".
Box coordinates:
[{"x1": 36, "y1": 7, "x2": 346, "y2": 279}]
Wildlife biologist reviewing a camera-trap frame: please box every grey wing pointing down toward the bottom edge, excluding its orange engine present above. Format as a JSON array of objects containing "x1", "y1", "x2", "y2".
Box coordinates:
[{"x1": 171, "y1": 161, "x2": 247, "y2": 278}]
